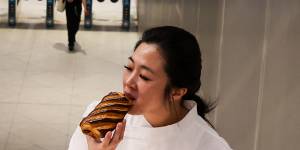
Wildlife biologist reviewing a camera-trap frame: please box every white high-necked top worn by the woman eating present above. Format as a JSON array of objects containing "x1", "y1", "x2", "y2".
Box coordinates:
[{"x1": 69, "y1": 101, "x2": 231, "y2": 150}]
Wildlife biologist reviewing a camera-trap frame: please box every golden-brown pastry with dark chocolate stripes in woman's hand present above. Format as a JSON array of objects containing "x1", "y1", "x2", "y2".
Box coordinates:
[{"x1": 80, "y1": 92, "x2": 132, "y2": 141}]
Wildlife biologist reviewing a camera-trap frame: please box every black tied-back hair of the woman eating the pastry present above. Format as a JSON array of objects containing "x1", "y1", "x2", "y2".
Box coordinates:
[{"x1": 135, "y1": 26, "x2": 214, "y2": 125}]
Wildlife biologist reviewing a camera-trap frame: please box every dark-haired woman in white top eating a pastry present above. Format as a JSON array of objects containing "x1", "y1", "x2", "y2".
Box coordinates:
[{"x1": 69, "y1": 26, "x2": 231, "y2": 150}]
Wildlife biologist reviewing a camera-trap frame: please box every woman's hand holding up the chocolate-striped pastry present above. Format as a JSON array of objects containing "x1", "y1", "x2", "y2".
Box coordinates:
[{"x1": 86, "y1": 121, "x2": 126, "y2": 150}]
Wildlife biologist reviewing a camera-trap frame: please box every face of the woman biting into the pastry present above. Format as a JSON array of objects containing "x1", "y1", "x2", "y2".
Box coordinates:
[{"x1": 123, "y1": 43, "x2": 168, "y2": 115}]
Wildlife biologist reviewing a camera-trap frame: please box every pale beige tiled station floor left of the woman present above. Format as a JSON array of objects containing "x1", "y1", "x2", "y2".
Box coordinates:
[{"x1": 0, "y1": 0, "x2": 138, "y2": 150}]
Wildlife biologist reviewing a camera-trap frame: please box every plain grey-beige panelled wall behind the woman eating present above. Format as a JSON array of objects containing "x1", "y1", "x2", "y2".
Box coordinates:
[{"x1": 138, "y1": 0, "x2": 300, "y2": 150}]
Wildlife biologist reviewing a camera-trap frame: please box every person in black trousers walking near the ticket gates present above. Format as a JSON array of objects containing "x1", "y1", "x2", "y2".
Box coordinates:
[{"x1": 66, "y1": 0, "x2": 88, "y2": 51}]
